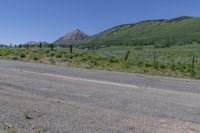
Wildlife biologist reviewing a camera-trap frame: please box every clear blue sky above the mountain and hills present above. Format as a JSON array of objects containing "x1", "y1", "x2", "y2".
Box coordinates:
[{"x1": 0, "y1": 0, "x2": 200, "y2": 44}]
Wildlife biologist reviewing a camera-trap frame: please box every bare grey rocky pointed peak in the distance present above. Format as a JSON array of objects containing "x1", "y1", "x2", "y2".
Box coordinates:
[{"x1": 54, "y1": 29, "x2": 89, "y2": 45}]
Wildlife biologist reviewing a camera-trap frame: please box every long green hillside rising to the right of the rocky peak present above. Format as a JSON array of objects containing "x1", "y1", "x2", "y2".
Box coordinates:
[{"x1": 78, "y1": 16, "x2": 200, "y2": 45}]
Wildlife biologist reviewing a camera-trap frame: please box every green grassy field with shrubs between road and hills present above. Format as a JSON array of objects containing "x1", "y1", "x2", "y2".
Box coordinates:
[{"x1": 0, "y1": 43, "x2": 200, "y2": 79}]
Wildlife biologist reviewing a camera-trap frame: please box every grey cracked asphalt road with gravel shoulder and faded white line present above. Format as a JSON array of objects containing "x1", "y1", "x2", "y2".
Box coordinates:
[{"x1": 0, "y1": 60, "x2": 200, "y2": 133}]
